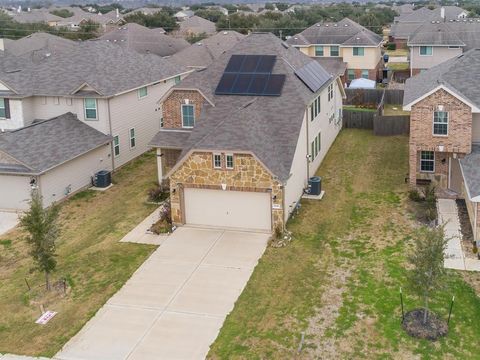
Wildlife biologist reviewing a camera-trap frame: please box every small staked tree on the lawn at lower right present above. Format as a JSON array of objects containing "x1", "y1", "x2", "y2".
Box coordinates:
[{"x1": 408, "y1": 226, "x2": 448, "y2": 324}]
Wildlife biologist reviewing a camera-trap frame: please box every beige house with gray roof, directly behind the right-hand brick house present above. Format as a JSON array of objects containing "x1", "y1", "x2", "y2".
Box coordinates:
[{"x1": 408, "y1": 19, "x2": 480, "y2": 76}]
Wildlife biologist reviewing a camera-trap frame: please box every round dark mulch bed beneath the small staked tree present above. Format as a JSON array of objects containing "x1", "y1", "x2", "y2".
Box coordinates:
[{"x1": 402, "y1": 309, "x2": 448, "y2": 341}]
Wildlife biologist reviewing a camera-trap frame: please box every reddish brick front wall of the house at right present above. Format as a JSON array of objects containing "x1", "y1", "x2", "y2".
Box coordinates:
[{"x1": 409, "y1": 89, "x2": 472, "y2": 188}]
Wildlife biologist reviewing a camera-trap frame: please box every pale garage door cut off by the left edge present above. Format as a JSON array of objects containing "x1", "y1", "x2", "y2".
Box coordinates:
[{"x1": 0, "y1": 175, "x2": 31, "y2": 210}]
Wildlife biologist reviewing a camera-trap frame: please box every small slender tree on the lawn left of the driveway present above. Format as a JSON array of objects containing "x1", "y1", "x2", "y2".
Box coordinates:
[{"x1": 20, "y1": 190, "x2": 60, "y2": 290}]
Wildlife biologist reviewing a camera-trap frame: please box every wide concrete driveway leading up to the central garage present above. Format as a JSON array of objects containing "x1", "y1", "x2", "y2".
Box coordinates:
[{"x1": 55, "y1": 227, "x2": 269, "y2": 360}]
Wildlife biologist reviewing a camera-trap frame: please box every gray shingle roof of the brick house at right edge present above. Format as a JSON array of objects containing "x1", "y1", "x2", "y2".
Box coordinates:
[{"x1": 403, "y1": 49, "x2": 480, "y2": 107}]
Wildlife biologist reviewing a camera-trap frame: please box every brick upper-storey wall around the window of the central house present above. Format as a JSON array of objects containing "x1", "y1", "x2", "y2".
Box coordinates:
[{"x1": 162, "y1": 90, "x2": 205, "y2": 129}]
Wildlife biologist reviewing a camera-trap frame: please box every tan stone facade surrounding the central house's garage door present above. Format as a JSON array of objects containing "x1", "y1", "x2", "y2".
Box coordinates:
[{"x1": 170, "y1": 152, "x2": 284, "y2": 230}]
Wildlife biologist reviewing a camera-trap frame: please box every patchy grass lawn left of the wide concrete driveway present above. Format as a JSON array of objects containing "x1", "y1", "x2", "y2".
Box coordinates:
[{"x1": 0, "y1": 153, "x2": 156, "y2": 356}]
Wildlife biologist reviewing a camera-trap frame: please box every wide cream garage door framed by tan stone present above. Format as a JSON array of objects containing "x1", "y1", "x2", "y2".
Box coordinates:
[{"x1": 184, "y1": 188, "x2": 272, "y2": 231}]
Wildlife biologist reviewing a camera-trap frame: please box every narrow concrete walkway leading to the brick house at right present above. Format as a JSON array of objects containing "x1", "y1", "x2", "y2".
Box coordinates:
[{"x1": 437, "y1": 199, "x2": 480, "y2": 271}]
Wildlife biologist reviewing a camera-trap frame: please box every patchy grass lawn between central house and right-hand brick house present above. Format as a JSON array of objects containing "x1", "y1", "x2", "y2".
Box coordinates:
[{"x1": 209, "y1": 129, "x2": 480, "y2": 359}]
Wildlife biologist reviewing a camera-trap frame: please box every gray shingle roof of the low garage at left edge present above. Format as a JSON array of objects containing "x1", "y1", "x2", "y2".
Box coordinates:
[{"x1": 0, "y1": 113, "x2": 112, "y2": 174}]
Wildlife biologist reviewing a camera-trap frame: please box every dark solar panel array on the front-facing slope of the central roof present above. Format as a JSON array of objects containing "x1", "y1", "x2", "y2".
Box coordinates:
[{"x1": 215, "y1": 55, "x2": 285, "y2": 96}]
